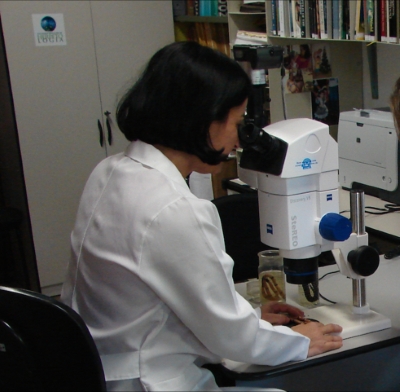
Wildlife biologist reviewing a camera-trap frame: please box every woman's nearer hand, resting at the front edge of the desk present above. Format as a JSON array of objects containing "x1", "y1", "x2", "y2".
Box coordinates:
[{"x1": 292, "y1": 322, "x2": 343, "y2": 357}]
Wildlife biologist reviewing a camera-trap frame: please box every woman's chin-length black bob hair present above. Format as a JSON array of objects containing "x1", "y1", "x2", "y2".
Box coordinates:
[{"x1": 116, "y1": 41, "x2": 251, "y2": 164}]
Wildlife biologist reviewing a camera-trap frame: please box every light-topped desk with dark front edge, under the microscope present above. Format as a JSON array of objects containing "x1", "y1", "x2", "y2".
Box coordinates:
[{"x1": 224, "y1": 256, "x2": 400, "y2": 391}]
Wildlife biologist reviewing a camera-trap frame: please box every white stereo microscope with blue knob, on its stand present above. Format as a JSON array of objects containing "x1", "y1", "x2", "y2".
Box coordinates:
[{"x1": 239, "y1": 119, "x2": 391, "y2": 338}]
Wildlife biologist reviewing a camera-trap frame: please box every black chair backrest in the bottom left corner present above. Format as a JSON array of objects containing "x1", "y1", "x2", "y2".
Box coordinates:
[{"x1": 0, "y1": 286, "x2": 106, "y2": 391}]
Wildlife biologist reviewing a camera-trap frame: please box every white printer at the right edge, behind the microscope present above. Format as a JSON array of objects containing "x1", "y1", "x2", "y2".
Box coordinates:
[{"x1": 338, "y1": 109, "x2": 400, "y2": 204}]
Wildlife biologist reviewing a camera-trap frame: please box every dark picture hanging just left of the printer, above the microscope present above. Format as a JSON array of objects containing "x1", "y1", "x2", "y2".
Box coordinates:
[{"x1": 311, "y1": 78, "x2": 340, "y2": 125}]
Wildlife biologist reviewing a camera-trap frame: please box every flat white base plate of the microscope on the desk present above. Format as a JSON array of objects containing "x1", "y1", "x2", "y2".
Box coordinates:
[{"x1": 304, "y1": 304, "x2": 392, "y2": 339}]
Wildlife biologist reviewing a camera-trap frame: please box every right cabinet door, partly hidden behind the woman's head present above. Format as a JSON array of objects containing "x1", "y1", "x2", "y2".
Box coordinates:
[{"x1": 91, "y1": 0, "x2": 174, "y2": 155}]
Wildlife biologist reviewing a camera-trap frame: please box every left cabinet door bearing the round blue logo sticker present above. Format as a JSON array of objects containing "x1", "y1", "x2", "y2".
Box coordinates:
[{"x1": 0, "y1": 1, "x2": 105, "y2": 294}]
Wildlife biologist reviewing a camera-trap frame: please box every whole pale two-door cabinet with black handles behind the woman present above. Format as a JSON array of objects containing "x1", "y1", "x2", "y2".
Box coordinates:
[{"x1": 0, "y1": 0, "x2": 174, "y2": 294}]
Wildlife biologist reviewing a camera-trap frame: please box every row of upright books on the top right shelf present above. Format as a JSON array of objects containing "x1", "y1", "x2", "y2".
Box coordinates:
[{"x1": 269, "y1": 0, "x2": 400, "y2": 43}]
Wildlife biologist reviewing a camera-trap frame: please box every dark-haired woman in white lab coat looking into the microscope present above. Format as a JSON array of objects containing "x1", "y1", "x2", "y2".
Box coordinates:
[{"x1": 62, "y1": 42, "x2": 342, "y2": 391}]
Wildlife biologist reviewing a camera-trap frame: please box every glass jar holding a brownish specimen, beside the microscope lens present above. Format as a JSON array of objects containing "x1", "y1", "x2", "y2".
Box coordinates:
[{"x1": 258, "y1": 249, "x2": 286, "y2": 304}]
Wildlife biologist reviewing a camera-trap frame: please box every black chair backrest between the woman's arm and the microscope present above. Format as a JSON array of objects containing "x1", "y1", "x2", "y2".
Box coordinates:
[{"x1": 212, "y1": 192, "x2": 270, "y2": 282}]
